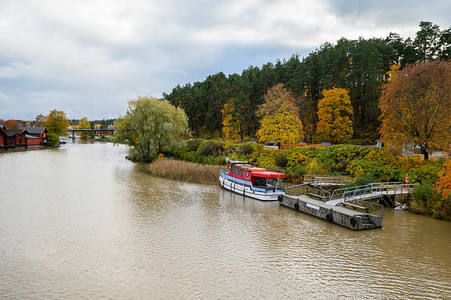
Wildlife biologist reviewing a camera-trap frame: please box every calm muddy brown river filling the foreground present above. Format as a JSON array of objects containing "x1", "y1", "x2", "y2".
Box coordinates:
[{"x1": 0, "y1": 143, "x2": 451, "y2": 299}]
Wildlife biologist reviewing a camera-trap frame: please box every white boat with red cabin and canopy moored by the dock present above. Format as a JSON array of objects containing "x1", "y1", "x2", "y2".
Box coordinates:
[{"x1": 219, "y1": 160, "x2": 285, "y2": 201}]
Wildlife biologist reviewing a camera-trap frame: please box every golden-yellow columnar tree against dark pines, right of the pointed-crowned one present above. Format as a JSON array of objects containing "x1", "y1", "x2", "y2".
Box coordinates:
[{"x1": 316, "y1": 88, "x2": 354, "y2": 143}]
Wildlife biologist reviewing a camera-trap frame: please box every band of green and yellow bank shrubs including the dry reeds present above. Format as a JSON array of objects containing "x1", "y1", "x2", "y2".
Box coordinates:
[{"x1": 153, "y1": 139, "x2": 451, "y2": 221}]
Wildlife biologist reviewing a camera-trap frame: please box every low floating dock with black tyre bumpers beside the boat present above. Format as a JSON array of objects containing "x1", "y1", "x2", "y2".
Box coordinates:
[{"x1": 280, "y1": 195, "x2": 383, "y2": 230}]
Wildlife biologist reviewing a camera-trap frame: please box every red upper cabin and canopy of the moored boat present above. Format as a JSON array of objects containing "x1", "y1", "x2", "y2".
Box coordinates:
[{"x1": 227, "y1": 161, "x2": 285, "y2": 188}]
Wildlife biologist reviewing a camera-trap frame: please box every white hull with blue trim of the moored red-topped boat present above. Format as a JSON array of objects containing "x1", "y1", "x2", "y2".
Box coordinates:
[{"x1": 219, "y1": 174, "x2": 284, "y2": 201}]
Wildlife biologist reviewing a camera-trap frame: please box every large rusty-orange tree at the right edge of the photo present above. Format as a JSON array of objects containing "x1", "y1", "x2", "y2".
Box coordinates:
[{"x1": 379, "y1": 61, "x2": 451, "y2": 159}]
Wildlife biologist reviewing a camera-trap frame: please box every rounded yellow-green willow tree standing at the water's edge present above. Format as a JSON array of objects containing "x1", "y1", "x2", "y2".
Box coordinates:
[{"x1": 116, "y1": 97, "x2": 189, "y2": 161}]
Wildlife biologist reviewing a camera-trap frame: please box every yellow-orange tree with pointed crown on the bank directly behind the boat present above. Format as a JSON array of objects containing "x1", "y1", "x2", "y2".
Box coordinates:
[{"x1": 257, "y1": 84, "x2": 304, "y2": 143}]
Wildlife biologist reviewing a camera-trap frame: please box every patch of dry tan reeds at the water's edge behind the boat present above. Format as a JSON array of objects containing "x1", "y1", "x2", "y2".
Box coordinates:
[{"x1": 149, "y1": 158, "x2": 221, "y2": 185}]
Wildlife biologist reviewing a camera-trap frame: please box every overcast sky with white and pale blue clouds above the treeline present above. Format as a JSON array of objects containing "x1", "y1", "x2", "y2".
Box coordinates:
[{"x1": 0, "y1": 0, "x2": 451, "y2": 120}]
